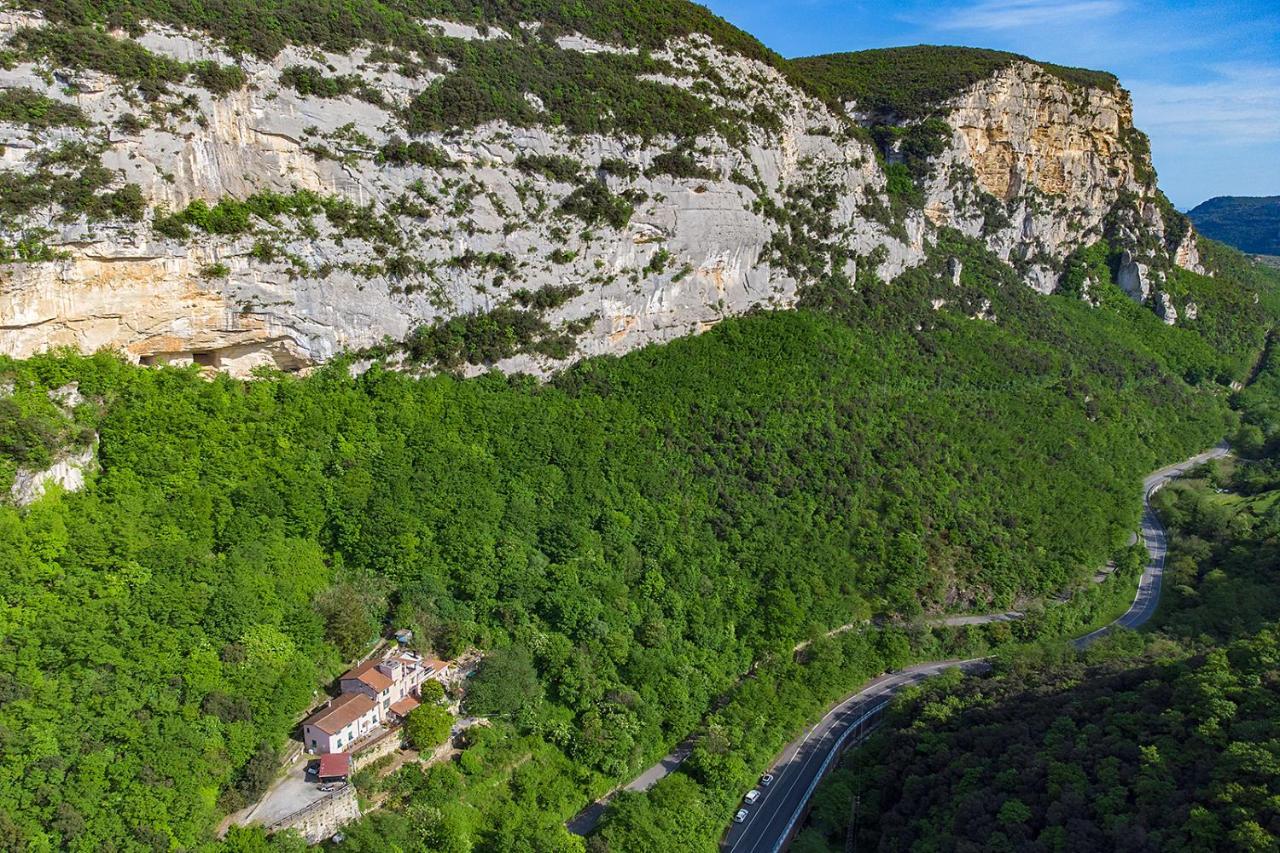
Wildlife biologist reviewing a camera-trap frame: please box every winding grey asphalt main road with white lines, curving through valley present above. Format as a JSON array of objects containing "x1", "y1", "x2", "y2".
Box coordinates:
[{"x1": 721, "y1": 443, "x2": 1229, "y2": 853}]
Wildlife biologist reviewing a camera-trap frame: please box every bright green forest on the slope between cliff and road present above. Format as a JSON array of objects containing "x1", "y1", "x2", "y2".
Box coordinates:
[{"x1": 0, "y1": 252, "x2": 1259, "y2": 849}]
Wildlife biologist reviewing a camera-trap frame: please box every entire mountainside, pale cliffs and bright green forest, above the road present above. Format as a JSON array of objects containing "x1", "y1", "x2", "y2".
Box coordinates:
[{"x1": 0, "y1": 0, "x2": 1280, "y2": 853}]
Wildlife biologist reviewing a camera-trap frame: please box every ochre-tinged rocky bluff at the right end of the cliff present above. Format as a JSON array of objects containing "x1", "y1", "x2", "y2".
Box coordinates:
[{"x1": 925, "y1": 61, "x2": 1177, "y2": 294}]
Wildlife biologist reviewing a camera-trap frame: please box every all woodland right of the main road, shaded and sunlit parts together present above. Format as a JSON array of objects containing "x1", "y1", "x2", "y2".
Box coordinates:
[{"x1": 795, "y1": 315, "x2": 1280, "y2": 853}]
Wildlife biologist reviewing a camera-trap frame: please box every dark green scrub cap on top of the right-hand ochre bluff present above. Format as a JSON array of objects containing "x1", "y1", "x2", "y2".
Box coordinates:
[{"x1": 792, "y1": 45, "x2": 1117, "y2": 119}]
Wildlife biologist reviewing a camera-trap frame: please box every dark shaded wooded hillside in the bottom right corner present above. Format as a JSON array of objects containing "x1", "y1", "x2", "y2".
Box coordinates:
[{"x1": 794, "y1": 629, "x2": 1280, "y2": 853}]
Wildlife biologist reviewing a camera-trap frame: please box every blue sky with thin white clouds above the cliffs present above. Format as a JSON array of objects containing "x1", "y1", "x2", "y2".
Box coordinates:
[{"x1": 703, "y1": 0, "x2": 1280, "y2": 209}]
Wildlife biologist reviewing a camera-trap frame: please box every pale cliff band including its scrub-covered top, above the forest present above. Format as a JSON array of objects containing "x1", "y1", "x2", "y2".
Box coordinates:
[{"x1": 0, "y1": 0, "x2": 1198, "y2": 374}]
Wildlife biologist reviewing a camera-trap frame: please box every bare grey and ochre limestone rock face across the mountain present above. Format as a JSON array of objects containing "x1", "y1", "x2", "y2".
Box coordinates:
[{"x1": 0, "y1": 9, "x2": 1197, "y2": 375}]
